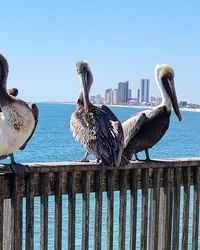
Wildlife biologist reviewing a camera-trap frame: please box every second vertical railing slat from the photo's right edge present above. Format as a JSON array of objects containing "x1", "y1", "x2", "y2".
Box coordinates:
[{"x1": 182, "y1": 168, "x2": 191, "y2": 250}]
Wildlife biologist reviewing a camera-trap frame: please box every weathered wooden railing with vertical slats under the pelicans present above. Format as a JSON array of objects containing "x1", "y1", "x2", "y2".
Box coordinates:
[{"x1": 0, "y1": 158, "x2": 200, "y2": 250}]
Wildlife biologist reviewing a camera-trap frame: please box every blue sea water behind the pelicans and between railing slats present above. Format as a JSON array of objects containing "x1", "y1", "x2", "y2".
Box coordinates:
[{"x1": 3, "y1": 104, "x2": 200, "y2": 250}]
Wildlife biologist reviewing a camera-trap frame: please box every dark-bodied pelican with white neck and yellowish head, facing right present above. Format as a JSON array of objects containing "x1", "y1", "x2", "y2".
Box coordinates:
[{"x1": 122, "y1": 64, "x2": 182, "y2": 160}]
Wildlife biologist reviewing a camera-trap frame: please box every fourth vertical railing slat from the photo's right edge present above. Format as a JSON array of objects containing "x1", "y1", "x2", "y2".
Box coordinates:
[{"x1": 163, "y1": 168, "x2": 173, "y2": 250}]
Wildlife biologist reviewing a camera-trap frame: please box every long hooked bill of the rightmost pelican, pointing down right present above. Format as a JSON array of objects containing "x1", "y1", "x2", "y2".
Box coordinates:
[{"x1": 167, "y1": 78, "x2": 182, "y2": 121}]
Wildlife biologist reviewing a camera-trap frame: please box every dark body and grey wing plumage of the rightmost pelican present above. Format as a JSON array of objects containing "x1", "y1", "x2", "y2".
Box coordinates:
[{"x1": 122, "y1": 106, "x2": 170, "y2": 160}]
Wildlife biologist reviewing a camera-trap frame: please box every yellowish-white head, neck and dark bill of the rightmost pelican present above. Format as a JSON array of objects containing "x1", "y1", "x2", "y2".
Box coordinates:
[{"x1": 155, "y1": 64, "x2": 182, "y2": 121}]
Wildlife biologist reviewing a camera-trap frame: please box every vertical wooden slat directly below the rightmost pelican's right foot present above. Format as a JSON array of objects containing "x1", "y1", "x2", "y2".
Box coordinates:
[{"x1": 140, "y1": 169, "x2": 149, "y2": 250}]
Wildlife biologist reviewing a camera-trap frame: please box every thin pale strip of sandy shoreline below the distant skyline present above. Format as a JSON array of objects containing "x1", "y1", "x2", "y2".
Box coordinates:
[{"x1": 40, "y1": 101, "x2": 200, "y2": 112}]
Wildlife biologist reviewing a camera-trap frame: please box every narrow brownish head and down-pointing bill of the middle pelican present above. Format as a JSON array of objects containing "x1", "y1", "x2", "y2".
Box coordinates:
[{"x1": 76, "y1": 60, "x2": 93, "y2": 112}]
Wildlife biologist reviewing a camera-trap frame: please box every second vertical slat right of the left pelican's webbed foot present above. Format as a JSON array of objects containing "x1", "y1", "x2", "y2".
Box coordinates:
[{"x1": 40, "y1": 174, "x2": 48, "y2": 250}]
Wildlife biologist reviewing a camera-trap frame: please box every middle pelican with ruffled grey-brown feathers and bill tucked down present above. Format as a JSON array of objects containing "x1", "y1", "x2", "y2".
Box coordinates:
[{"x1": 70, "y1": 61, "x2": 128, "y2": 166}]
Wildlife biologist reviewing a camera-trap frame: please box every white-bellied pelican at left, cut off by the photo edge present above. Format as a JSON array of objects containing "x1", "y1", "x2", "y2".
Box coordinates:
[{"x1": 0, "y1": 54, "x2": 38, "y2": 174}]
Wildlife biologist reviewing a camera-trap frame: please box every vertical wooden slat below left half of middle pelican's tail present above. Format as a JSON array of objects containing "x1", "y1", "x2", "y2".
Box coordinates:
[{"x1": 107, "y1": 171, "x2": 114, "y2": 250}]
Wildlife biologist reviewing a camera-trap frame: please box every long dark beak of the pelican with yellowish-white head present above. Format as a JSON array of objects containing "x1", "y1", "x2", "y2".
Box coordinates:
[{"x1": 163, "y1": 77, "x2": 182, "y2": 121}]
